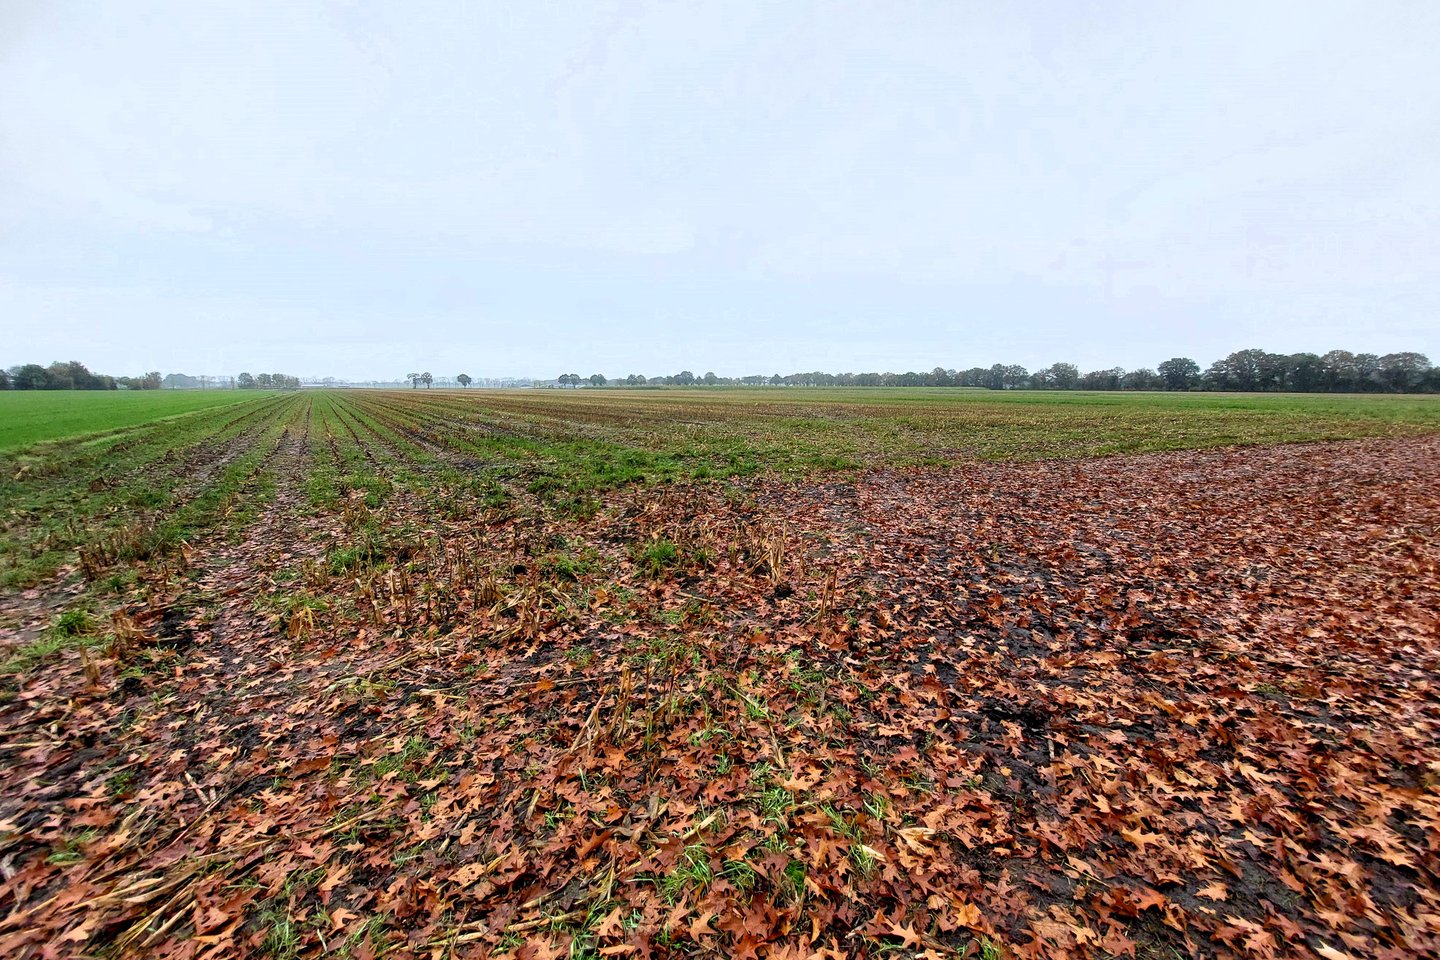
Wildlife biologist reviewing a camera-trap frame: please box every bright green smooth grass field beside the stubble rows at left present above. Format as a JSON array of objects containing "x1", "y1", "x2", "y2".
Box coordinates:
[{"x1": 0, "y1": 390, "x2": 263, "y2": 450}]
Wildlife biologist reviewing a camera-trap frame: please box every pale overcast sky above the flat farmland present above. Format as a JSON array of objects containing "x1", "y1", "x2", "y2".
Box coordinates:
[{"x1": 0, "y1": 0, "x2": 1440, "y2": 379}]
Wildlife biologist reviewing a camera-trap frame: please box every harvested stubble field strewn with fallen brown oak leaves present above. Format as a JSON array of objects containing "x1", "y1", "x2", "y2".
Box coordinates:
[{"x1": 0, "y1": 390, "x2": 1440, "y2": 959}]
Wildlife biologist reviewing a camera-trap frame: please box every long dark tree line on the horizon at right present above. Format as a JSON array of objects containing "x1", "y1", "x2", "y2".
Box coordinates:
[{"x1": 570, "y1": 350, "x2": 1440, "y2": 393}]
